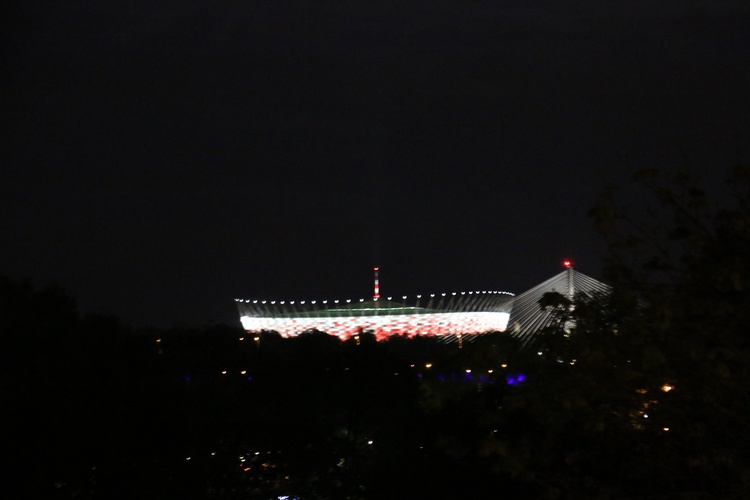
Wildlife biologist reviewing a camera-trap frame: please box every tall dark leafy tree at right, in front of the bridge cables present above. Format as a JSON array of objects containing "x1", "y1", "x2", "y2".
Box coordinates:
[{"x1": 491, "y1": 166, "x2": 750, "y2": 498}]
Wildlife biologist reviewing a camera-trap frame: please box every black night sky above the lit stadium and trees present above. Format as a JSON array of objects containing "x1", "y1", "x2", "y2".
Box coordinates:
[{"x1": 0, "y1": 0, "x2": 750, "y2": 326}]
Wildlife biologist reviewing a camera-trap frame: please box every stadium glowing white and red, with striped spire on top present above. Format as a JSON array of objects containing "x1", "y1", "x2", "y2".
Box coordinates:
[{"x1": 235, "y1": 268, "x2": 514, "y2": 340}]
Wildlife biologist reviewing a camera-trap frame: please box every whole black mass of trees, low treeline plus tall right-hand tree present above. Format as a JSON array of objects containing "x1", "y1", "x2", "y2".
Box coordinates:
[{"x1": 0, "y1": 167, "x2": 750, "y2": 499}]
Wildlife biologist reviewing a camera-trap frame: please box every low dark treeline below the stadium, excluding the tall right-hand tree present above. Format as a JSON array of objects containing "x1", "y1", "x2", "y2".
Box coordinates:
[{"x1": 1, "y1": 284, "x2": 527, "y2": 498}]
